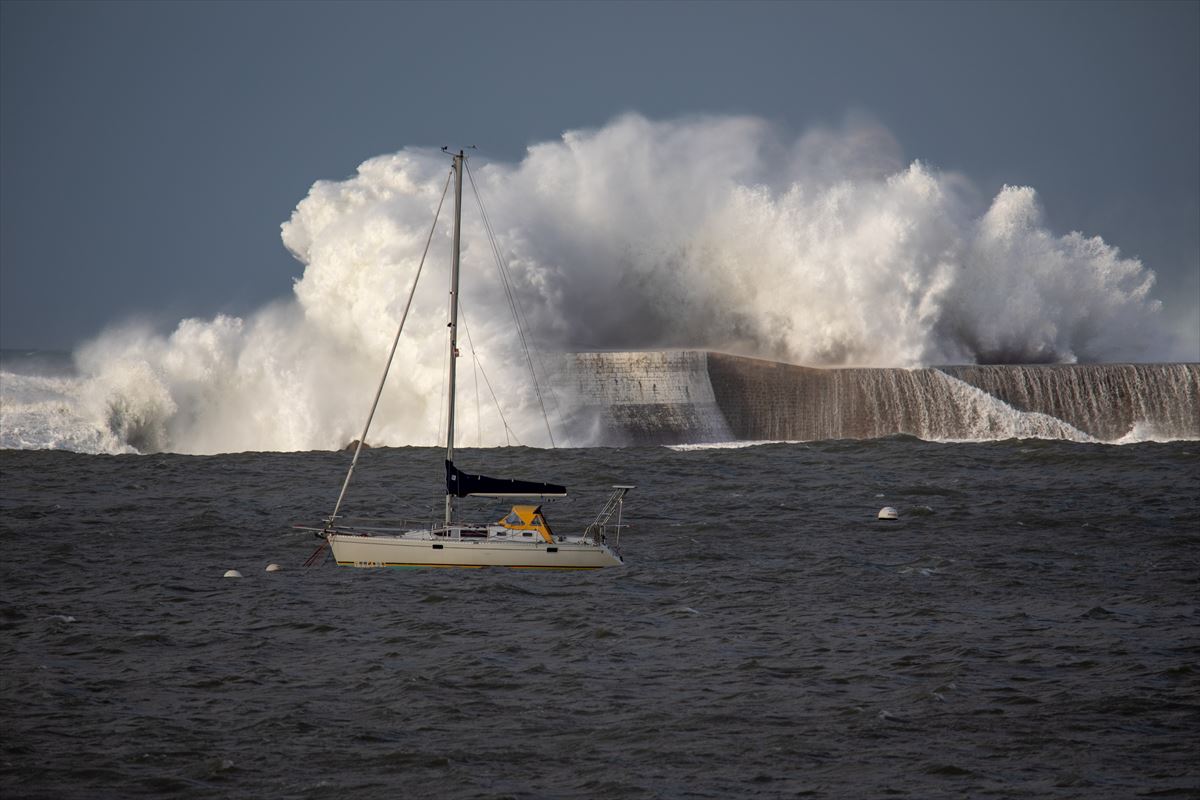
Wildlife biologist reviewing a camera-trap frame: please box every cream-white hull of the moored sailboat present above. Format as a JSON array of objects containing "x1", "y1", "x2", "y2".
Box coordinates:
[{"x1": 325, "y1": 534, "x2": 622, "y2": 570}]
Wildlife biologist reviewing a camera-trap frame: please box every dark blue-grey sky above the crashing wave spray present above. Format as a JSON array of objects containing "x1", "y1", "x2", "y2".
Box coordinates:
[{"x1": 0, "y1": 0, "x2": 1200, "y2": 357}]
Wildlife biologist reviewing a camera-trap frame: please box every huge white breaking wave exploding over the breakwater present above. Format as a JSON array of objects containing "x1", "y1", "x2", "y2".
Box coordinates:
[{"x1": 0, "y1": 114, "x2": 1170, "y2": 453}]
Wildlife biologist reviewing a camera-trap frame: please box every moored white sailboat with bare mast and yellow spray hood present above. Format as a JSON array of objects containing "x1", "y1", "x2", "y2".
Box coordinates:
[{"x1": 310, "y1": 148, "x2": 635, "y2": 570}]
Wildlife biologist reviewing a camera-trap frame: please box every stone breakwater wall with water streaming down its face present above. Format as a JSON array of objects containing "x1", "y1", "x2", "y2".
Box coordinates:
[{"x1": 556, "y1": 350, "x2": 1200, "y2": 445}]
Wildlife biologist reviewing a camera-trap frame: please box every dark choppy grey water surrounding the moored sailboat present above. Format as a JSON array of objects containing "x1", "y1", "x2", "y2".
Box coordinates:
[{"x1": 0, "y1": 438, "x2": 1200, "y2": 798}]
